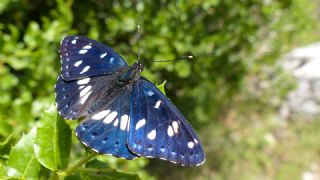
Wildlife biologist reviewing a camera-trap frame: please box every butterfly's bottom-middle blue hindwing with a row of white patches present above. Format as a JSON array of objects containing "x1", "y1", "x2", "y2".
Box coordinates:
[{"x1": 76, "y1": 88, "x2": 139, "y2": 159}]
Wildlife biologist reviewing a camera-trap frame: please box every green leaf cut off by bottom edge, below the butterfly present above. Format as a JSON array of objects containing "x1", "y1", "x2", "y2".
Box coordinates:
[{"x1": 80, "y1": 168, "x2": 140, "y2": 180}]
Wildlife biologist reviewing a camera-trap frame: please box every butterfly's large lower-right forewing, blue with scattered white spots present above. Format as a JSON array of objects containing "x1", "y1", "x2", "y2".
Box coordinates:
[{"x1": 128, "y1": 77, "x2": 205, "y2": 166}]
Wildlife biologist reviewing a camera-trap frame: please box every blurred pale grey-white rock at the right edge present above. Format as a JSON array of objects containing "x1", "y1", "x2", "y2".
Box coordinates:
[{"x1": 280, "y1": 43, "x2": 320, "y2": 120}]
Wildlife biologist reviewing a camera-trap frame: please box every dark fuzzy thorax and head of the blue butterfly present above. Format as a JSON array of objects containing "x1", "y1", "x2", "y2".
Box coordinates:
[{"x1": 116, "y1": 62, "x2": 143, "y2": 87}]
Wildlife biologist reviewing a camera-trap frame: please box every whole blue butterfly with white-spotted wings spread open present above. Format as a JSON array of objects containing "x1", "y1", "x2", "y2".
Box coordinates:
[{"x1": 55, "y1": 35, "x2": 205, "y2": 166}]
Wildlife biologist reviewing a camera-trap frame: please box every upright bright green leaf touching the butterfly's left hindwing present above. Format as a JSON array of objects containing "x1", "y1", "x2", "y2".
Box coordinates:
[{"x1": 34, "y1": 105, "x2": 71, "y2": 170}]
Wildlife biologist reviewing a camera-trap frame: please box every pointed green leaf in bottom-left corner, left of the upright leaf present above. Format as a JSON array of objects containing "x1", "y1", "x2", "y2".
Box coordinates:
[{"x1": 7, "y1": 128, "x2": 40, "y2": 179}]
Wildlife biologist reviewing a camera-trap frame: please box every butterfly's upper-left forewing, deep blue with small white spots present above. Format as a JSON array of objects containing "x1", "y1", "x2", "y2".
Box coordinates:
[{"x1": 60, "y1": 36, "x2": 127, "y2": 81}]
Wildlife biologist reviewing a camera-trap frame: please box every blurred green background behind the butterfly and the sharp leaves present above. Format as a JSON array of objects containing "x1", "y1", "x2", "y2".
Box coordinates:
[{"x1": 0, "y1": 0, "x2": 320, "y2": 180}]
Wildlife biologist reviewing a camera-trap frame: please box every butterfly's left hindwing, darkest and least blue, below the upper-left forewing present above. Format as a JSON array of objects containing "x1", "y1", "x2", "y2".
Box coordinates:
[{"x1": 55, "y1": 71, "x2": 122, "y2": 119}]
